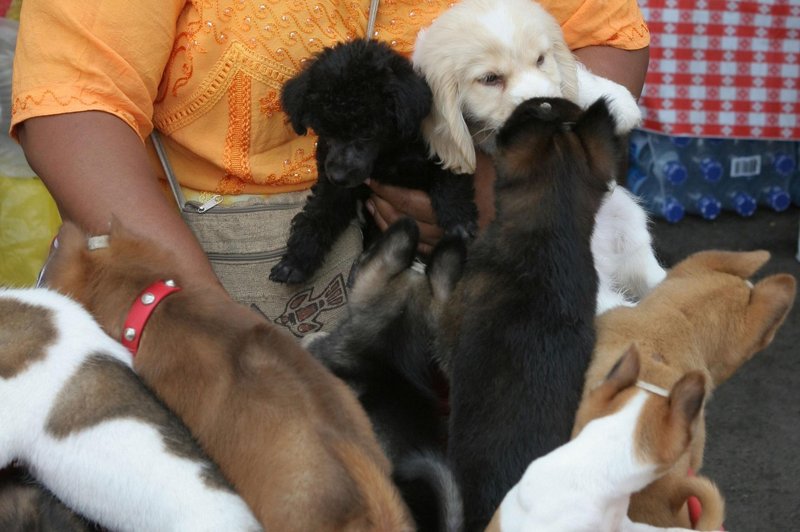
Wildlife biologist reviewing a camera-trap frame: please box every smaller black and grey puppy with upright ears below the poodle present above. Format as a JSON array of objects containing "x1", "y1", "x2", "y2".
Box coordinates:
[{"x1": 308, "y1": 218, "x2": 466, "y2": 532}]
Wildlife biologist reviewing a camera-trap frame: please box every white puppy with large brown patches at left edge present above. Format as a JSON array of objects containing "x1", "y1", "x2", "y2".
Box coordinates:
[{"x1": 0, "y1": 289, "x2": 261, "y2": 531}]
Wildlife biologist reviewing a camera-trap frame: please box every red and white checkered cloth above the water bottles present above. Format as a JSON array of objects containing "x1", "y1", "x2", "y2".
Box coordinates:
[{"x1": 639, "y1": 0, "x2": 800, "y2": 140}]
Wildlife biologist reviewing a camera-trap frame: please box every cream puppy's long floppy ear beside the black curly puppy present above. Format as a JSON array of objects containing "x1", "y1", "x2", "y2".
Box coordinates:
[{"x1": 412, "y1": 30, "x2": 475, "y2": 174}]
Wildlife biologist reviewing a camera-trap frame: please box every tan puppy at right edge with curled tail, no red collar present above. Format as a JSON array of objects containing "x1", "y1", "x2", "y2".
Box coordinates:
[{"x1": 573, "y1": 251, "x2": 796, "y2": 530}]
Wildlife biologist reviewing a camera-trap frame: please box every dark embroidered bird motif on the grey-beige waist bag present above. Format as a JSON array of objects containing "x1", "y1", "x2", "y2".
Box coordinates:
[{"x1": 275, "y1": 274, "x2": 347, "y2": 338}]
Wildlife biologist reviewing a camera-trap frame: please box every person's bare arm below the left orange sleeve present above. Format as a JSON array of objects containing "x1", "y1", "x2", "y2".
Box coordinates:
[{"x1": 18, "y1": 111, "x2": 218, "y2": 284}]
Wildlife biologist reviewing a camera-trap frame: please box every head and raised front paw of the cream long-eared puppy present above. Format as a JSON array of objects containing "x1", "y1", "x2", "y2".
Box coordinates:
[{"x1": 412, "y1": 0, "x2": 641, "y2": 177}]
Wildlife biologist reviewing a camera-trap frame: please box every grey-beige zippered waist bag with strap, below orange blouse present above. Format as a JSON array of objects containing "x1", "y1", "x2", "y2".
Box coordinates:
[{"x1": 152, "y1": 132, "x2": 363, "y2": 337}]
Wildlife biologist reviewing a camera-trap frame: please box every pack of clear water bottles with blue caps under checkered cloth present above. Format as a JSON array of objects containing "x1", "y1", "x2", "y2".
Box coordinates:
[{"x1": 627, "y1": 130, "x2": 800, "y2": 223}]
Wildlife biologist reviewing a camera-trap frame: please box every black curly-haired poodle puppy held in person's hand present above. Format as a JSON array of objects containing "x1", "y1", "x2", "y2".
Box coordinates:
[{"x1": 270, "y1": 39, "x2": 477, "y2": 283}]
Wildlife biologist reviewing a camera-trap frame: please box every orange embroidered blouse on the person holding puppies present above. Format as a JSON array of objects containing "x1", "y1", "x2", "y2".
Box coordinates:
[{"x1": 11, "y1": 0, "x2": 649, "y2": 194}]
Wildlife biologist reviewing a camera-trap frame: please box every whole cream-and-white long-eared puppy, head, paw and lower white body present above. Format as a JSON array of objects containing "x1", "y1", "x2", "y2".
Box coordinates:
[{"x1": 412, "y1": 0, "x2": 666, "y2": 314}]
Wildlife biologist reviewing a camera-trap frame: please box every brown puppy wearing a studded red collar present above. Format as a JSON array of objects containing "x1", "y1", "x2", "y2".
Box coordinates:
[{"x1": 45, "y1": 223, "x2": 411, "y2": 531}]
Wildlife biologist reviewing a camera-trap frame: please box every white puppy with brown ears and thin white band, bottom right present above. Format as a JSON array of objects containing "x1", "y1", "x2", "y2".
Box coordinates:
[{"x1": 488, "y1": 348, "x2": 706, "y2": 532}]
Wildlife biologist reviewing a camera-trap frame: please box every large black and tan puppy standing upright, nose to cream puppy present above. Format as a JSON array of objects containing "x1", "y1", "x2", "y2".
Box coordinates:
[{"x1": 440, "y1": 98, "x2": 618, "y2": 530}]
